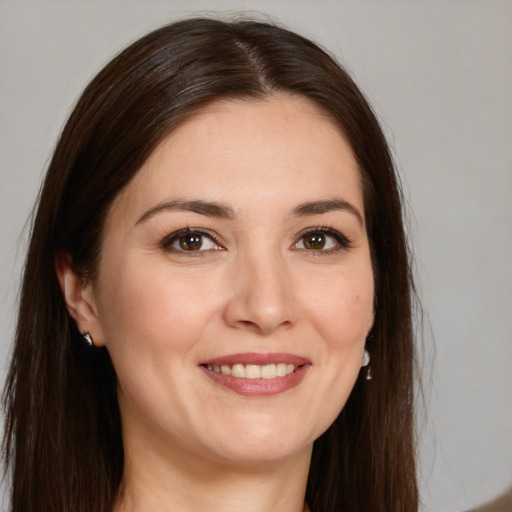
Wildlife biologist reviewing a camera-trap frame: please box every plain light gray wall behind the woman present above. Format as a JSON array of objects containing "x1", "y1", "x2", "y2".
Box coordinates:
[{"x1": 0, "y1": 0, "x2": 512, "y2": 512}]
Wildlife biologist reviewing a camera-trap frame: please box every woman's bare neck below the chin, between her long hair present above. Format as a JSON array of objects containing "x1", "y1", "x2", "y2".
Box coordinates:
[{"x1": 114, "y1": 436, "x2": 311, "y2": 512}]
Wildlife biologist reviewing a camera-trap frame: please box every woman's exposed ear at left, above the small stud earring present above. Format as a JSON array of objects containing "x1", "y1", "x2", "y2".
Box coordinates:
[{"x1": 55, "y1": 251, "x2": 102, "y2": 346}]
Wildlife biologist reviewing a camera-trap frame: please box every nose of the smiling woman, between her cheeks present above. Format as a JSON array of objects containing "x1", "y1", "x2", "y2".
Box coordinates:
[{"x1": 224, "y1": 250, "x2": 296, "y2": 335}]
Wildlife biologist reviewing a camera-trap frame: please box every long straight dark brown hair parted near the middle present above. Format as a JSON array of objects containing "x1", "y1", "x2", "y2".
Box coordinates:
[{"x1": 4, "y1": 19, "x2": 418, "y2": 512}]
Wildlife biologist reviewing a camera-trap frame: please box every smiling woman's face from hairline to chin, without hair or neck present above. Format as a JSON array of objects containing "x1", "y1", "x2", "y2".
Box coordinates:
[{"x1": 88, "y1": 97, "x2": 374, "y2": 463}]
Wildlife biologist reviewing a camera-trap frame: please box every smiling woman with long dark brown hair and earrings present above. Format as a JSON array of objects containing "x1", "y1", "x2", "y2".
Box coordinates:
[{"x1": 4, "y1": 19, "x2": 418, "y2": 512}]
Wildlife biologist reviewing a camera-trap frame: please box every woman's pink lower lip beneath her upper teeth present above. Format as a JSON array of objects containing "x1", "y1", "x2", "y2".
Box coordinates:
[{"x1": 200, "y1": 364, "x2": 311, "y2": 396}]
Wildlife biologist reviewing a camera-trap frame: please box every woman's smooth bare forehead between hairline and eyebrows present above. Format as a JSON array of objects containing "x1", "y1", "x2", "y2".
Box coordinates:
[{"x1": 108, "y1": 96, "x2": 362, "y2": 224}]
